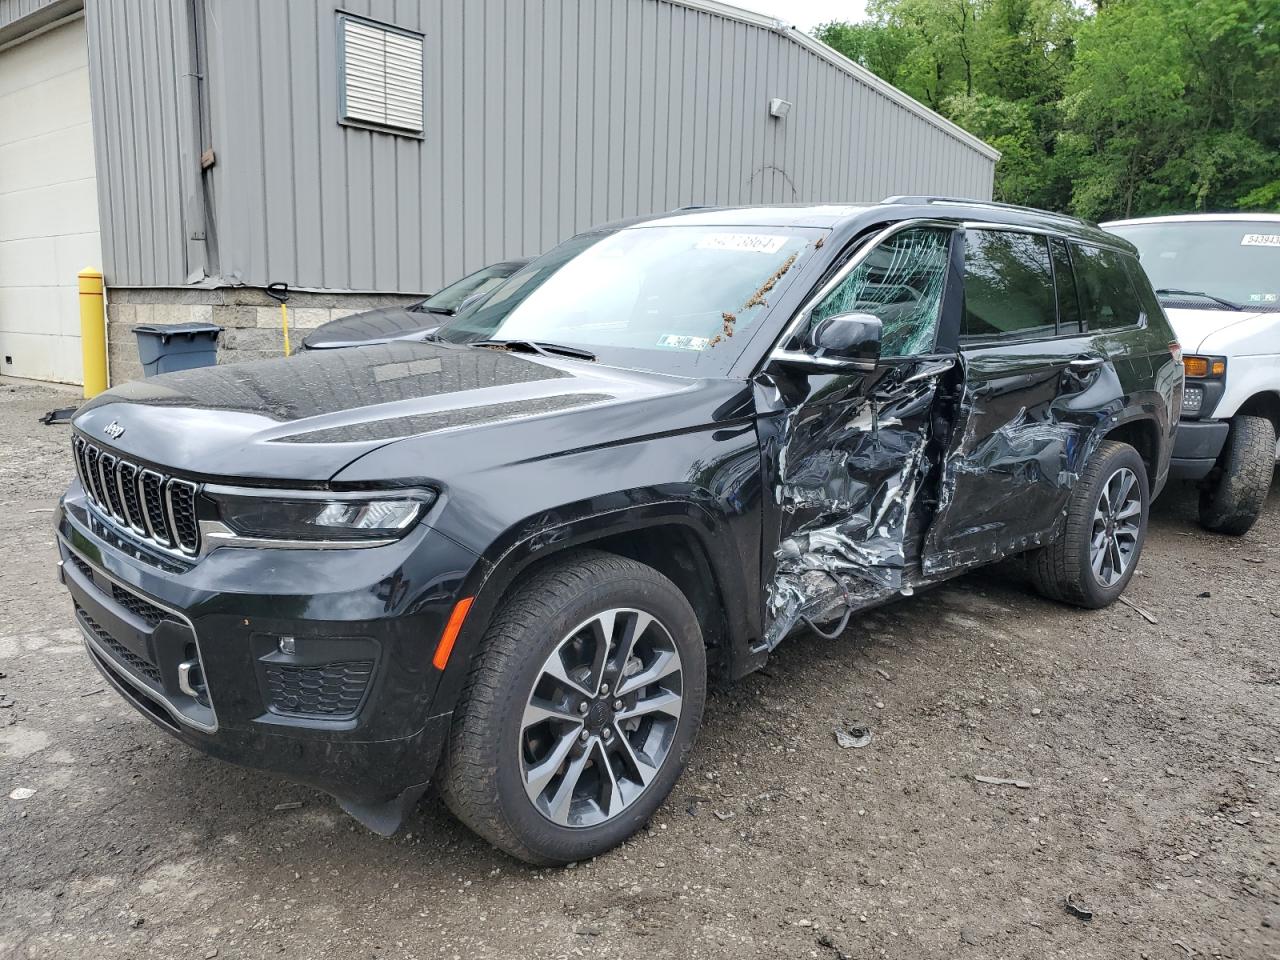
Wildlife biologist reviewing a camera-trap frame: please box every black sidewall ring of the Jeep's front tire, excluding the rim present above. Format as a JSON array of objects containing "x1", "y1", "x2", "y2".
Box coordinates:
[{"x1": 492, "y1": 576, "x2": 707, "y2": 863}]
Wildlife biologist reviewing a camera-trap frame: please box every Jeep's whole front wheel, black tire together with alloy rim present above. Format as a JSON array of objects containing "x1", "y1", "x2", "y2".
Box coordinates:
[{"x1": 439, "y1": 550, "x2": 707, "y2": 865}]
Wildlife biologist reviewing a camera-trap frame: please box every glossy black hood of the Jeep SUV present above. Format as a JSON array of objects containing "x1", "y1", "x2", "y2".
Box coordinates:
[{"x1": 73, "y1": 340, "x2": 711, "y2": 483}]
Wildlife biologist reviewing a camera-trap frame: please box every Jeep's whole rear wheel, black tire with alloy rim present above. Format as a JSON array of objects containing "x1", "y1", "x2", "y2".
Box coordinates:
[{"x1": 1028, "y1": 440, "x2": 1151, "y2": 609}]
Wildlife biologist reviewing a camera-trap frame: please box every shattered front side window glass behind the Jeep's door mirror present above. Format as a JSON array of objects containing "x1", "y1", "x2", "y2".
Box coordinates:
[{"x1": 809, "y1": 227, "x2": 951, "y2": 357}]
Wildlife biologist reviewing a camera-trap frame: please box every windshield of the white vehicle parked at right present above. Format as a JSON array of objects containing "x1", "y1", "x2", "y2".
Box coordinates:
[{"x1": 1107, "y1": 219, "x2": 1280, "y2": 310}]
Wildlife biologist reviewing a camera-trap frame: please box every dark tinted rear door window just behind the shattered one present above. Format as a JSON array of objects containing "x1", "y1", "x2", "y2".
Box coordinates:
[{"x1": 960, "y1": 230, "x2": 1057, "y2": 340}]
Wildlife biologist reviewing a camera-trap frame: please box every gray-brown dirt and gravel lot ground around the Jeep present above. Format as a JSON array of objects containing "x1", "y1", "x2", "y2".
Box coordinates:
[{"x1": 0, "y1": 381, "x2": 1280, "y2": 960}]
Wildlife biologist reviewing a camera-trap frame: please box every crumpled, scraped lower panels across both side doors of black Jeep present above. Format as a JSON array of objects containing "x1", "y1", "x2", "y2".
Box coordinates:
[{"x1": 764, "y1": 360, "x2": 1103, "y2": 649}]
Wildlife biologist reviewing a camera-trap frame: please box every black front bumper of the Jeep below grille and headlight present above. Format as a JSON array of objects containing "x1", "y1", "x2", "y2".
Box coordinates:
[{"x1": 58, "y1": 486, "x2": 477, "y2": 832}]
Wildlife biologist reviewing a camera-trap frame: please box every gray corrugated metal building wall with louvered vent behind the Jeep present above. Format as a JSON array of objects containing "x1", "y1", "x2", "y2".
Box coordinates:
[{"x1": 0, "y1": 0, "x2": 997, "y2": 380}]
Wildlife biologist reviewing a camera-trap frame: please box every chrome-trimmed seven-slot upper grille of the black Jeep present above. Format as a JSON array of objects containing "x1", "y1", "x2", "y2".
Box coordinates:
[{"x1": 72, "y1": 435, "x2": 200, "y2": 556}]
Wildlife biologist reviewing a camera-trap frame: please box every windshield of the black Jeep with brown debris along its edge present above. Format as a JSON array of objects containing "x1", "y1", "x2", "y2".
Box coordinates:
[{"x1": 436, "y1": 225, "x2": 827, "y2": 376}]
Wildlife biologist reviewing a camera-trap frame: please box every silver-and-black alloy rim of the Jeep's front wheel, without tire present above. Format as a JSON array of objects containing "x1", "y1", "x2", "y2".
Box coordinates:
[{"x1": 518, "y1": 608, "x2": 682, "y2": 827}]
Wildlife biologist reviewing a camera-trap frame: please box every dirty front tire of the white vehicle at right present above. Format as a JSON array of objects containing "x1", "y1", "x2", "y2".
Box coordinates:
[{"x1": 1199, "y1": 416, "x2": 1276, "y2": 536}]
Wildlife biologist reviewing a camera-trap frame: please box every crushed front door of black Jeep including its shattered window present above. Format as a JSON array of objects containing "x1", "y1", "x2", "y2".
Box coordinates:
[{"x1": 756, "y1": 224, "x2": 956, "y2": 649}]
